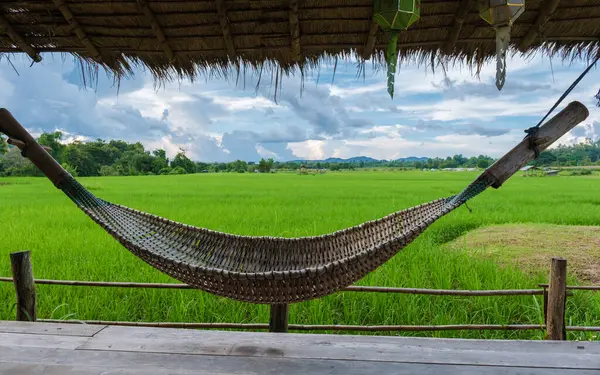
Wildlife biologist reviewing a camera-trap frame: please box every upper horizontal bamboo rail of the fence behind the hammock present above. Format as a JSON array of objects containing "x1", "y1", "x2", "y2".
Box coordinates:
[{"x1": 0, "y1": 277, "x2": 544, "y2": 297}]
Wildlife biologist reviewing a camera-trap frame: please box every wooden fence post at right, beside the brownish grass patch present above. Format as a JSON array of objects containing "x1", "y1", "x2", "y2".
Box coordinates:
[{"x1": 546, "y1": 257, "x2": 567, "y2": 340}]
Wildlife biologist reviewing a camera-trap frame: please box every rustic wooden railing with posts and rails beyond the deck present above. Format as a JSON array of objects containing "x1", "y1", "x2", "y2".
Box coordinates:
[{"x1": 0, "y1": 251, "x2": 600, "y2": 340}]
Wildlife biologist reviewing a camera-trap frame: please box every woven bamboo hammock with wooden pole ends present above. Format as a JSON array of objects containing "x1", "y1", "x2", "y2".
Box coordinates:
[{"x1": 0, "y1": 102, "x2": 588, "y2": 304}]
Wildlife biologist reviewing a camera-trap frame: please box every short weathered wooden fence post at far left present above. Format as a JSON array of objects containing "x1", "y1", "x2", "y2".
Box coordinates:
[{"x1": 10, "y1": 251, "x2": 37, "y2": 322}]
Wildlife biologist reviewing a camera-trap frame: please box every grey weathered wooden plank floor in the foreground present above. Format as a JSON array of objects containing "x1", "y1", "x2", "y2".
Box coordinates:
[{"x1": 0, "y1": 321, "x2": 600, "y2": 375}]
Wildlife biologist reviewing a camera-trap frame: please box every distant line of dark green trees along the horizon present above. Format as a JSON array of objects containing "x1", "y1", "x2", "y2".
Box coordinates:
[{"x1": 0, "y1": 132, "x2": 600, "y2": 176}]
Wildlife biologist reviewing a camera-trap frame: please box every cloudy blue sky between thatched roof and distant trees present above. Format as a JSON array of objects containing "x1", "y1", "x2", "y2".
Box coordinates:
[{"x1": 0, "y1": 50, "x2": 600, "y2": 161}]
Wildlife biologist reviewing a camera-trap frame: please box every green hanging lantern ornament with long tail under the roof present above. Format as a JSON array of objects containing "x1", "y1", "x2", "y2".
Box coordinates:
[{"x1": 373, "y1": 0, "x2": 421, "y2": 99}]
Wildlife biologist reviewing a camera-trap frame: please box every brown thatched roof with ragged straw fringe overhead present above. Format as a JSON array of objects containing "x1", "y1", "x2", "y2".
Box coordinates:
[{"x1": 0, "y1": 0, "x2": 600, "y2": 83}]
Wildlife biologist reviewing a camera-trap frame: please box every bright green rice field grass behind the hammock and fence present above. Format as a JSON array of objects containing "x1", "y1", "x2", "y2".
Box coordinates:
[{"x1": 0, "y1": 172, "x2": 600, "y2": 339}]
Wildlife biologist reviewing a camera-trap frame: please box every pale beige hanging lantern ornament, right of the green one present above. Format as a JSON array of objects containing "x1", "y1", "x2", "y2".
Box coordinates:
[{"x1": 479, "y1": 0, "x2": 525, "y2": 90}]
